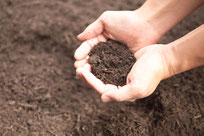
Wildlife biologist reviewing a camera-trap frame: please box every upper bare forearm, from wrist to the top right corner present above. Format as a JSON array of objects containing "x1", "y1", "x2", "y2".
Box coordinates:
[{"x1": 136, "y1": 0, "x2": 204, "y2": 36}]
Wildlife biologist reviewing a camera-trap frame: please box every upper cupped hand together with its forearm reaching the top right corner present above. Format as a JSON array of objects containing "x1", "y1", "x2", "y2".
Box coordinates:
[{"x1": 75, "y1": 0, "x2": 204, "y2": 57}]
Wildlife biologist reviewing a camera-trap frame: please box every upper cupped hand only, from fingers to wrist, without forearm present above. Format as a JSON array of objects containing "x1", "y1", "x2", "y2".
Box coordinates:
[{"x1": 75, "y1": 11, "x2": 160, "y2": 61}]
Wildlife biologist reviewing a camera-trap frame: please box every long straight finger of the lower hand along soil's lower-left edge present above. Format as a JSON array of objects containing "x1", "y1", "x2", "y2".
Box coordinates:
[{"x1": 77, "y1": 68, "x2": 105, "y2": 94}]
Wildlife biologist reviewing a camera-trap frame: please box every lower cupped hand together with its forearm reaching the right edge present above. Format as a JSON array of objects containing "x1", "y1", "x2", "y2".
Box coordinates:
[{"x1": 77, "y1": 25, "x2": 204, "y2": 102}]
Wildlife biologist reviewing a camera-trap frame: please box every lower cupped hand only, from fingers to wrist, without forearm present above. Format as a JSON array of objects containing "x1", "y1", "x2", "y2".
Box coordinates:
[{"x1": 77, "y1": 45, "x2": 170, "y2": 102}]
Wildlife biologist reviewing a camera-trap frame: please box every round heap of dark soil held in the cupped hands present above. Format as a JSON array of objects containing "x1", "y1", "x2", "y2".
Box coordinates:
[{"x1": 88, "y1": 40, "x2": 136, "y2": 86}]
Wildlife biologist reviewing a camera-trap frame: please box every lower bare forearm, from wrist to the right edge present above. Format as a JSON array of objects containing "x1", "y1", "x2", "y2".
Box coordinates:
[{"x1": 167, "y1": 25, "x2": 204, "y2": 76}]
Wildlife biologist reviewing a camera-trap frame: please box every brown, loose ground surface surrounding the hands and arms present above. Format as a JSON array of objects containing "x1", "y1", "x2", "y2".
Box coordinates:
[{"x1": 0, "y1": 0, "x2": 204, "y2": 136}]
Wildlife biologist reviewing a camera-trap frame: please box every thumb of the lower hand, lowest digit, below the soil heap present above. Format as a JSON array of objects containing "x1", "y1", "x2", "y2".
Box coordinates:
[{"x1": 101, "y1": 84, "x2": 136, "y2": 102}]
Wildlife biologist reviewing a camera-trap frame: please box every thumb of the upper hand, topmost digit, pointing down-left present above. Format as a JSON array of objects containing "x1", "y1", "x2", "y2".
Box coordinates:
[{"x1": 77, "y1": 19, "x2": 104, "y2": 41}]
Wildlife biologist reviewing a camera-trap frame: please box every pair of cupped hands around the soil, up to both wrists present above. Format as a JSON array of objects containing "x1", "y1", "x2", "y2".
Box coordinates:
[{"x1": 74, "y1": 11, "x2": 172, "y2": 102}]
